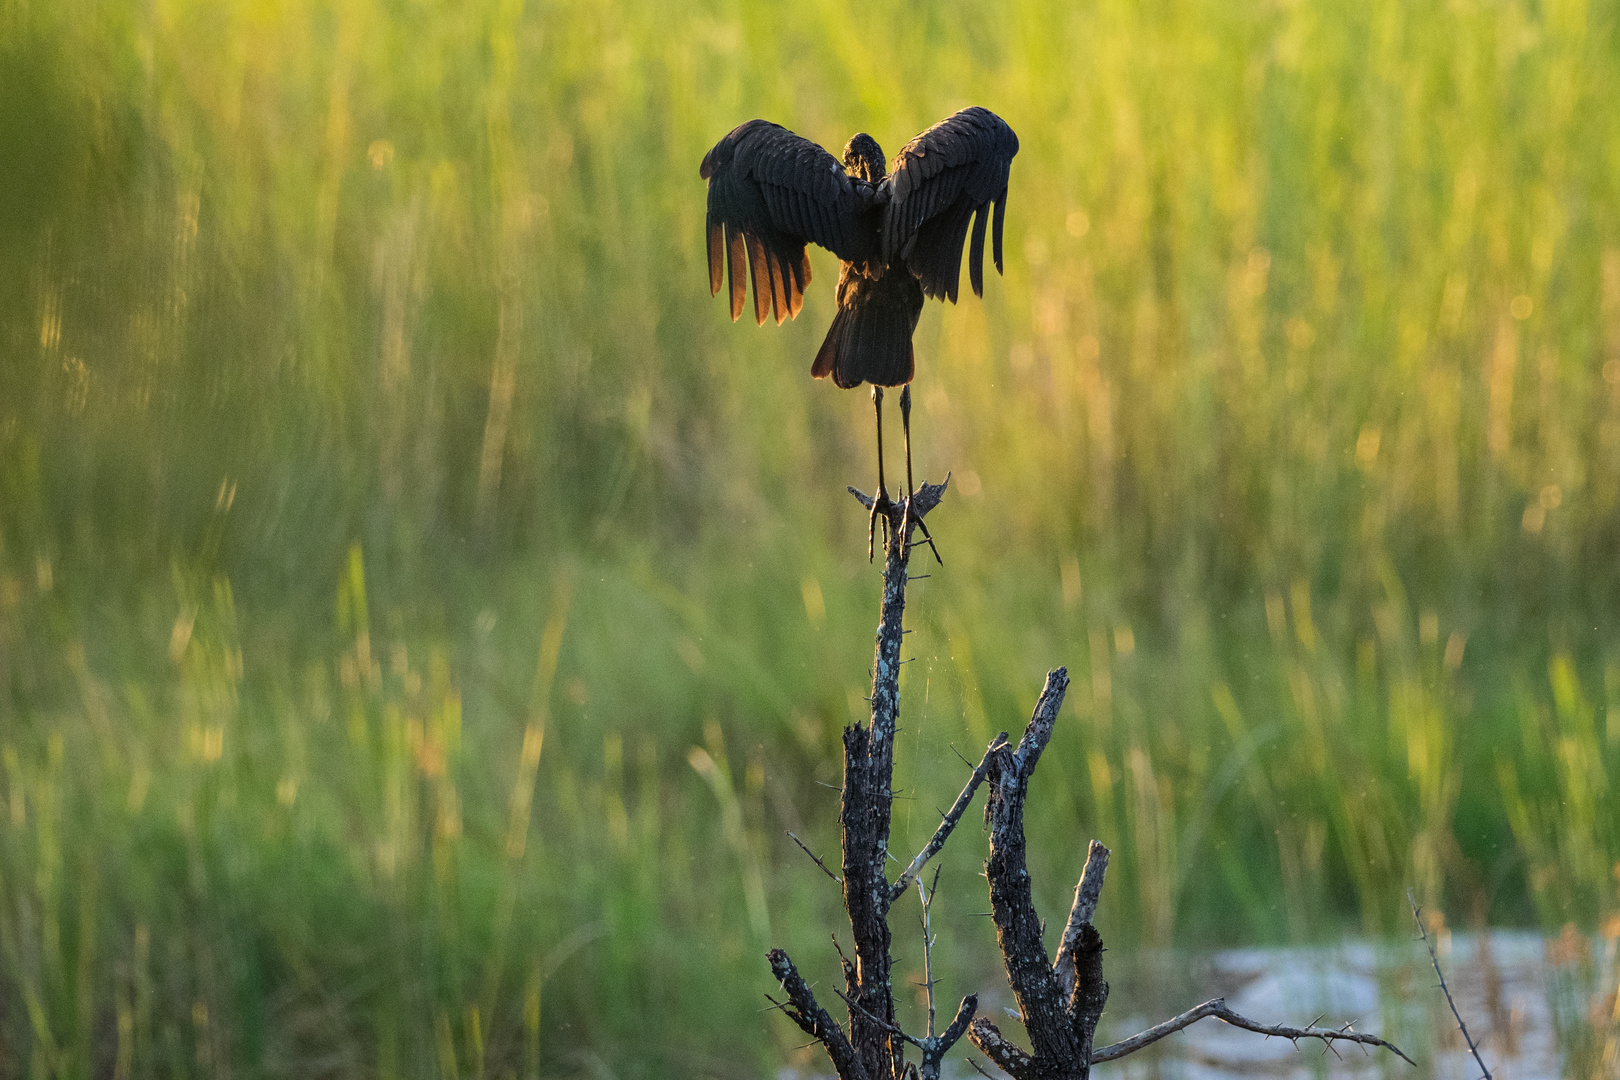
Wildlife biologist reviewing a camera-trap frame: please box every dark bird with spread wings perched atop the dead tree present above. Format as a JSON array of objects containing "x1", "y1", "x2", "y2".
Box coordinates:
[{"x1": 698, "y1": 105, "x2": 1019, "y2": 559}]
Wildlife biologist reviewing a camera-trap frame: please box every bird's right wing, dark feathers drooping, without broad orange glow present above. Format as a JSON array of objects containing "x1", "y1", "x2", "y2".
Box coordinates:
[{"x1": 883, "y1": 105, "x2": 1017, "y2": 303}]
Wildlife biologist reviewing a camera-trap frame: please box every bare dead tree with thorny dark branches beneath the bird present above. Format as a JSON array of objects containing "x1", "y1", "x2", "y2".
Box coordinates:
[{"x1": 768, "y1": 478, "x2": 1411, "y2": 1080}]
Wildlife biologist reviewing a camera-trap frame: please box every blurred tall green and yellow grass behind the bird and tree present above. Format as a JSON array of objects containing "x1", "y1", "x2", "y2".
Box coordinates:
[{"x1": 0, "y1": 0, "x2": 1620, "y2": 1077}]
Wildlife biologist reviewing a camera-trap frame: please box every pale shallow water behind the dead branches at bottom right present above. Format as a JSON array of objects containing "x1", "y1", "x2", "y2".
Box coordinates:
[{"x1": 781, "y1": 931, "x2": 1620, "y2": 1080}]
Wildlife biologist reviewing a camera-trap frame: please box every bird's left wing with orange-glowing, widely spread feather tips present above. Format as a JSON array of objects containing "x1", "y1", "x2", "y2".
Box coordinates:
[{"x1": 698, "y1": 120, "x2": 876, "y2": 324}]
